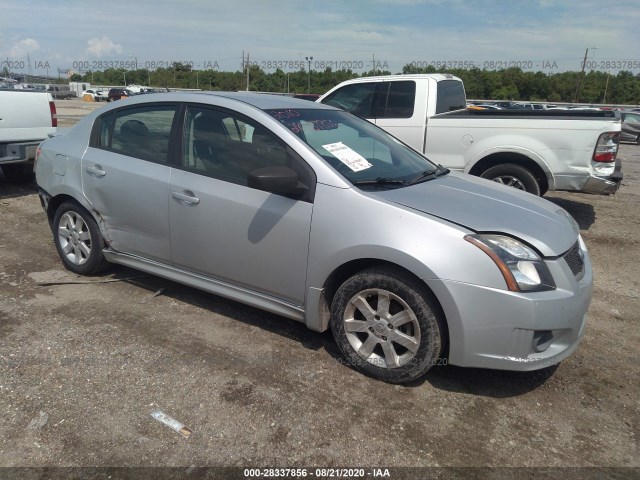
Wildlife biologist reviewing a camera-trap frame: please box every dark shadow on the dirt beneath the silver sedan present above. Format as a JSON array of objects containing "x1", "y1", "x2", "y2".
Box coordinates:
[{"x1": 109, "y1": 266, "x2": 557, "y2": 398}]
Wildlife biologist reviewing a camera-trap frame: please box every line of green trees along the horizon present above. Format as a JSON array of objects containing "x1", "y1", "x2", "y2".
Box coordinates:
[{"x1": 71, "y1": 63, "x2": 640, "y2": 105}]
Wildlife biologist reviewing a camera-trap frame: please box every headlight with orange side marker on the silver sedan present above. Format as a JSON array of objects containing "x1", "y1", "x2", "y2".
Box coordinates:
[{"x1": 464, "y1": 234, "x2": 556, "y2": 292}]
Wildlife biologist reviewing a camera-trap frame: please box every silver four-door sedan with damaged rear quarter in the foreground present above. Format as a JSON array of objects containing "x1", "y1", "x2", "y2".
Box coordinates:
[{"x1": 36, "y1": 92, "x2": 592, "y2": 383}]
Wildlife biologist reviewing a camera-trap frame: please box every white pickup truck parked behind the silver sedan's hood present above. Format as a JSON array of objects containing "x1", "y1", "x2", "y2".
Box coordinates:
[{"x1": 317, "y1": 74, "x2": 622, "y2": 195}]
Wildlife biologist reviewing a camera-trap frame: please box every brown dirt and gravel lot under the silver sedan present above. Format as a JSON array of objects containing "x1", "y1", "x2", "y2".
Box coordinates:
[{"x1": 0, "y1": 102, "x2": 640, "y2": 478}]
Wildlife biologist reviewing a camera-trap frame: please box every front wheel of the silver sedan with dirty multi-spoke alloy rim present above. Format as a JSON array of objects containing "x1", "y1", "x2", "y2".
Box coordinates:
[{"x1": 331, "y1": 268, "x2": 444, "y2": 383}]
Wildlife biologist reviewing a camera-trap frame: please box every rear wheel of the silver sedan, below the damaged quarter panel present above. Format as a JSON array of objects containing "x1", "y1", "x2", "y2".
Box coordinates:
[{"x1": 52, "y1": 202, "x2": 107, "y2": 275}]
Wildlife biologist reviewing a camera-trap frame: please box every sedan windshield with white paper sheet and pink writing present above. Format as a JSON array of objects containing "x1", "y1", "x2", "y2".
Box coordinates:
[{"x1": 267, "y1": 109, "x2": 437, "y2": 189}]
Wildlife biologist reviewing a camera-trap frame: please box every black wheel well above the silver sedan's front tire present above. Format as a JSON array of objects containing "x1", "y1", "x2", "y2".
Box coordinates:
[{"x1": 323, "y1": 258, "x2": 449, "y2": 357}]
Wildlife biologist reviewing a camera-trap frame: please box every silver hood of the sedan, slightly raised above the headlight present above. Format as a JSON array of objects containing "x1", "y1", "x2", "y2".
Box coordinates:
[{"x1": 373, "y1": 172, "x2": 579, "y2": 257}]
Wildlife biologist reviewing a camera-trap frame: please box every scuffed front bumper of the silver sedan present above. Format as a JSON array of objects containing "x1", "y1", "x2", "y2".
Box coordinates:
[{"x1": 430, "y1": 248, "x2": 593, "y2": 371}]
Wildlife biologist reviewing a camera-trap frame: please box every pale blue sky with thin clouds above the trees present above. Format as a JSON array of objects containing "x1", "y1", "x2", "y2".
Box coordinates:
[{"x1": 0, "y1": 0, "x2": 640, "y2": 75}]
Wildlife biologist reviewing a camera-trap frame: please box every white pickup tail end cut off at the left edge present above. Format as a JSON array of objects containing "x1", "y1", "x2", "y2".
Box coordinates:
[{"x1": 0, "y1": 89, "x2": 58, "y2": 183}]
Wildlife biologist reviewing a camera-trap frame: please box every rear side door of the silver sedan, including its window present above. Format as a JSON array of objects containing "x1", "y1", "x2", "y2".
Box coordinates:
[{"x1": 82, "y1": 104, "x2": 176, "y2": 262}]
